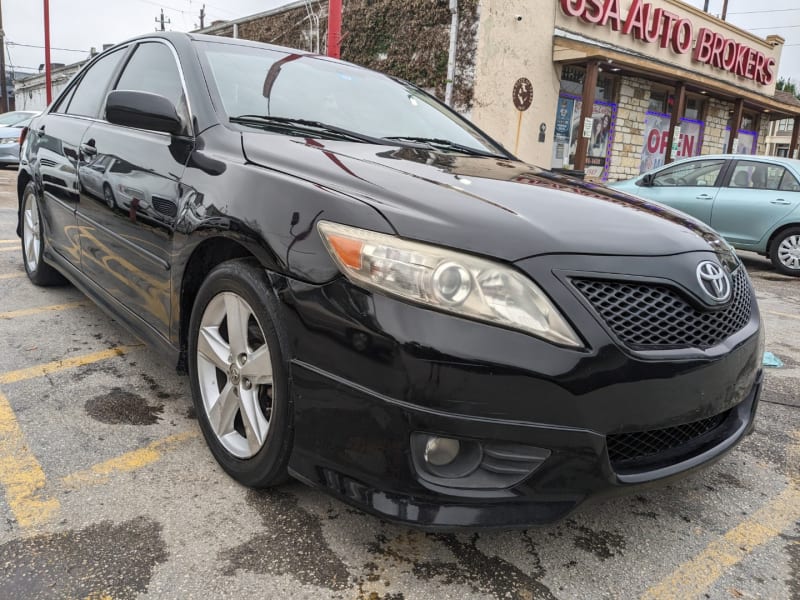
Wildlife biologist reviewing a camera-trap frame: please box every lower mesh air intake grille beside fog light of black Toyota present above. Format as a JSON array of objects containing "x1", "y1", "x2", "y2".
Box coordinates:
[{"x1": 606, "y1": 410, "x2": 731, "y2": 471}]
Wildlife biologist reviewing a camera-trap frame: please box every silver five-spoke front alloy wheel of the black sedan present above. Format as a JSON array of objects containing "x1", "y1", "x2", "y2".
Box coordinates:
[{"x1": 197, "y1": 292, "x2": 273, "y2": 459}]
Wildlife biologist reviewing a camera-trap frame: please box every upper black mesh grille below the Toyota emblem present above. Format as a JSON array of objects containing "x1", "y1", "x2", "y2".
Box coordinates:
[{"x1": 573, "y1": 269, "x2": 751, "y2": 350}]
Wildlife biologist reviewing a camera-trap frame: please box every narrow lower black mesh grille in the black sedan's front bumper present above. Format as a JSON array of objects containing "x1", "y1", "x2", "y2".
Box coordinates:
[{"x1": 606, "y1": 410, "x2": 731, "y2": 467}]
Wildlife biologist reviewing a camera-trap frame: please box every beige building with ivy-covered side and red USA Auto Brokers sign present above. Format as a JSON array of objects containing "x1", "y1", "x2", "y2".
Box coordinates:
[{"x1": 197, "y1": 0, "x2": 800, "y2": 180}]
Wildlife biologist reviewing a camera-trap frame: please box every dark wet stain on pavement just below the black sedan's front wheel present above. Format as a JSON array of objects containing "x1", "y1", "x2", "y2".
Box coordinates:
[{"x1": 220, "y1": 490, "x2": 350, "y2": 591}]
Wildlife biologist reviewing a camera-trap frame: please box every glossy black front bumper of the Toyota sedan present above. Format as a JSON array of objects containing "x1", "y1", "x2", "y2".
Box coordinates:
[{"x1": 273, "y1": 255, "x2": 763, "y2": 529}]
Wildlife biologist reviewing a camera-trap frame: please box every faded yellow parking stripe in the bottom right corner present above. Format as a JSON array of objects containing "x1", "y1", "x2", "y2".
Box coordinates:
[{"x1": 642, "y1": 432, "x2": 800, "y2": 600}]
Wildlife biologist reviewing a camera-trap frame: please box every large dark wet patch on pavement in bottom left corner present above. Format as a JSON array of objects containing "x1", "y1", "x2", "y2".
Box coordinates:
[{"x1": 0, "y1": 517, "x2": 168, "y2": 600}]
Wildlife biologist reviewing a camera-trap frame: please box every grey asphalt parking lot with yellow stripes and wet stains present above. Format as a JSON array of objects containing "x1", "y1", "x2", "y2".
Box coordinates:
[{"x1": 0, "y1": 169, "x2": 800, "y2": 600}]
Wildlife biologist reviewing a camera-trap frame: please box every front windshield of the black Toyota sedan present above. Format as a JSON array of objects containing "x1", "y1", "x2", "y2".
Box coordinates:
[{"x1": 199, "y1": 42, "x2": 505, "y2": 155}]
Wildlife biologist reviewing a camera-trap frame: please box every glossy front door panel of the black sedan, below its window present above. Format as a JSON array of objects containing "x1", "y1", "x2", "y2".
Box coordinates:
[{"x1": 77, "y1": 122, "x2": 189, "y2": 337}]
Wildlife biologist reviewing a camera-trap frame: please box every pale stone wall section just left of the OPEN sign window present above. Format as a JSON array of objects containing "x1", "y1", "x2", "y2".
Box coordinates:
[{"x1": 608, "y1": 77, "x2": 650, "y2": 181}]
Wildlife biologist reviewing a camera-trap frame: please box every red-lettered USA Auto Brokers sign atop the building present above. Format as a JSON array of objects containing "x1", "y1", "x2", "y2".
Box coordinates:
[{"x1": 560, "y1": 0, "x2": 775, "y2": 85}]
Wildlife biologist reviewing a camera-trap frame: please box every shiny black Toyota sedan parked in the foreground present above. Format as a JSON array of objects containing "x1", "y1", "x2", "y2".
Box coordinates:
[{"x1": 18, "y1": 33, "x2": 763, "y2": 528}]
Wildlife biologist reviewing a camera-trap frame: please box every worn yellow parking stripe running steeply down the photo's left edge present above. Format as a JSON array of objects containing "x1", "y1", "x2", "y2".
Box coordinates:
[{"x1": 0, "y1": 392, "x2": 59, "y2": 527}]
